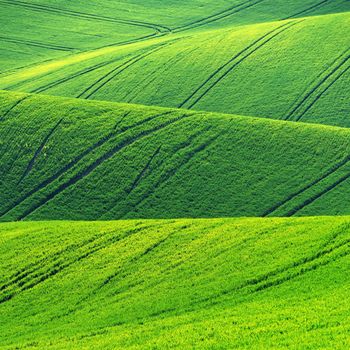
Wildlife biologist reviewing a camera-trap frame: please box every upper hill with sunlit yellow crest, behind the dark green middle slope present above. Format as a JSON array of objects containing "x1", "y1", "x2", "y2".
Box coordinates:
[{"x1": 0, "y1": 13, "x2": 350, "y2": 127}]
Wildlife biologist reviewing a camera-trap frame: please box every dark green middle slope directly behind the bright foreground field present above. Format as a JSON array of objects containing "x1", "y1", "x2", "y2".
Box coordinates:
[{"x1": 0, "y1": 92, "x2": 350, "y2": 221}]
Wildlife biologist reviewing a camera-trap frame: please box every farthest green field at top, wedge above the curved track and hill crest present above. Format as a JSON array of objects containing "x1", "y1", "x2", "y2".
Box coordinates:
[{"x1": 22, "y1": 0, "x2": 349, "y2": 31}]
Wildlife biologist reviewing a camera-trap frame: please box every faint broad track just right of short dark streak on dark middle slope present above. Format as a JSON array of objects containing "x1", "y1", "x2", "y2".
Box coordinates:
[{"x1": 119, "y1": 126, "x2": 223, "y2": 219}]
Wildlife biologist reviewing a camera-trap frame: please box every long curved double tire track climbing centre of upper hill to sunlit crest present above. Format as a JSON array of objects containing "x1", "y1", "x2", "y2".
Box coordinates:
[{"x1": 178, "y1": 20, "x2": 302, "y2": 109}]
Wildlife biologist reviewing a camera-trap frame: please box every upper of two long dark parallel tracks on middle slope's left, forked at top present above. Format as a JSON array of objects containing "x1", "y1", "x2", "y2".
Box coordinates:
[{"x1": 0, "y1": 111, "x2": 172, "y2": 217}]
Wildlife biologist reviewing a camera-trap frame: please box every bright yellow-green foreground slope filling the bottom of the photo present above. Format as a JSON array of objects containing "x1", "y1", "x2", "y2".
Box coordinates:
[{"x1": 0, "y1": 217, "x2": 350, "y2": 349}]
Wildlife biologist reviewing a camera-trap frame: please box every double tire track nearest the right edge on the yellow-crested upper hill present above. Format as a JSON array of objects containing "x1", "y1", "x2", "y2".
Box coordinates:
[{"x1": 283, "y1": 48, "x2": 350, "y2": 121}]
